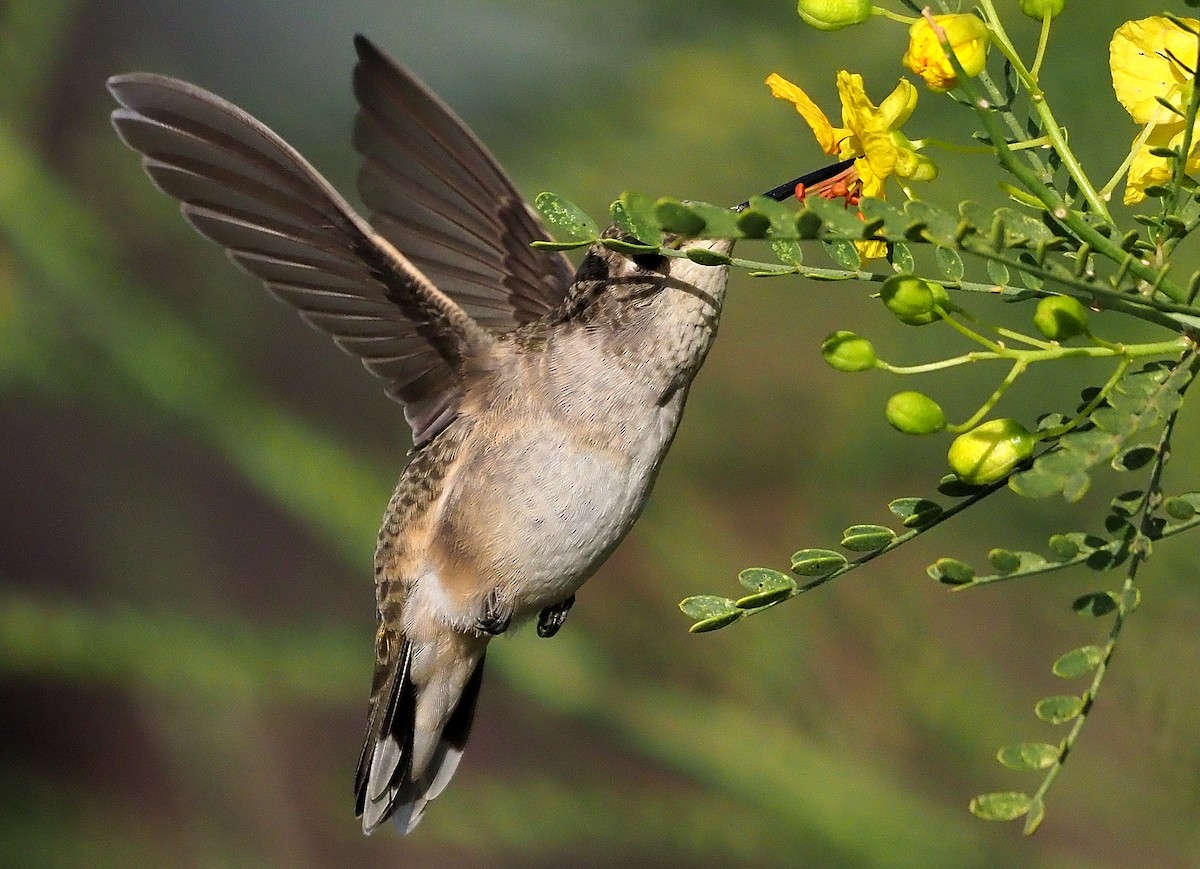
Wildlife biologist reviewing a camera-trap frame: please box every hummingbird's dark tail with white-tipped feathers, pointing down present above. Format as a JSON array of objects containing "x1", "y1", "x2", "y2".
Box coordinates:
[{"x1": 354, "y1": 635, "x2": 486, "y2": 835}]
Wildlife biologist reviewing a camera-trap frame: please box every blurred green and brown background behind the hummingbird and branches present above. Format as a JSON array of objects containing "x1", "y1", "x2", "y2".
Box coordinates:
[{"x1": 0, "y1": 0, "x2": 1200, "y2": 869}]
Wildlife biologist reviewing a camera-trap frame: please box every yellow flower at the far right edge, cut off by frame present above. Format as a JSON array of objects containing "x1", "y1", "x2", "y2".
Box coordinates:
[{"x1": 1109, "y1": 16, "x2": 1200, "y2": 205}]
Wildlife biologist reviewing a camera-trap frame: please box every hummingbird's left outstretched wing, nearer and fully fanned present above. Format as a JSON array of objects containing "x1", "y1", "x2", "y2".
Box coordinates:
[{"x1": 108, "y1": 73, "x2": 493, "y2": 445}]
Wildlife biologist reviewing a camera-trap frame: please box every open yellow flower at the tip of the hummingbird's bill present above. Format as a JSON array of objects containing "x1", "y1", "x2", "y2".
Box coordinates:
[{"x1": 767, "y1": 70, "x2": 937, "y2": 257}]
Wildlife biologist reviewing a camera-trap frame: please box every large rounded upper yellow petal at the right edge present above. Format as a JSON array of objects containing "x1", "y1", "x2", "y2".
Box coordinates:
[{"x1": 1109, "y1": 16, "x2": 1200, "y2": 124}]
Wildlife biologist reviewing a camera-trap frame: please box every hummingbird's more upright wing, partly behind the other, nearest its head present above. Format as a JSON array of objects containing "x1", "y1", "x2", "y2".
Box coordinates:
[{"x1": 354, "y1": 36, "x2": 574, "y2": 331}]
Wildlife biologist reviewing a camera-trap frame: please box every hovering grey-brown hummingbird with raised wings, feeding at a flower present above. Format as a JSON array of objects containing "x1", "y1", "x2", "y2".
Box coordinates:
[{"x1": 108, "y1": 36, "x2": 848, "y2": 834}]
